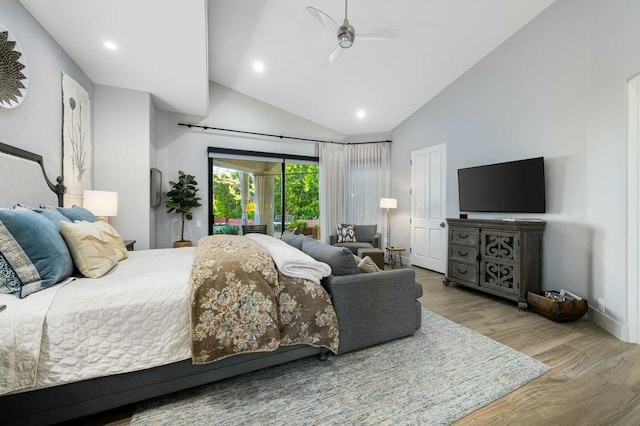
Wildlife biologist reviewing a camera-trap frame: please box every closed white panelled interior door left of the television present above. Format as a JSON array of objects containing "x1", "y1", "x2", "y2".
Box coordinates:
[{"x1": 411, "y1": 143, "x2": 447, "y2": 273}]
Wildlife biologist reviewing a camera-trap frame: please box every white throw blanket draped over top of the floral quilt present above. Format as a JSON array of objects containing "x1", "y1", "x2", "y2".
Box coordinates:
[{"x1": 245, "y1": 234, "x2": 331, "y2": 284}]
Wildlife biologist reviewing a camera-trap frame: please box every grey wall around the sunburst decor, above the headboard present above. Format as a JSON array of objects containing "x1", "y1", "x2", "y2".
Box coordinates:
[{"x1": 0, "y1": 0, "x2": 93, "y2": 184}]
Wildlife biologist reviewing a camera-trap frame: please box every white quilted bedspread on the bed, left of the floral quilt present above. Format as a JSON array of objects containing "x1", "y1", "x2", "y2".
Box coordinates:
[{"x1": 0, "y1": 247, "x2": 195, "y2": 390}]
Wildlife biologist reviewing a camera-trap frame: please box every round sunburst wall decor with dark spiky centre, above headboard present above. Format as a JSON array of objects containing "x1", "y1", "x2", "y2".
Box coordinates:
[{"x1": 0, "y1": 25, "x2": 28, "y2": 108}]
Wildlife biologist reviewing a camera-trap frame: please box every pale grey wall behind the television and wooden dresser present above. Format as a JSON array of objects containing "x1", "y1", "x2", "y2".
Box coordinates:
[{"x1": 391, "y1": 0, "x2": 640, "y2": 339}]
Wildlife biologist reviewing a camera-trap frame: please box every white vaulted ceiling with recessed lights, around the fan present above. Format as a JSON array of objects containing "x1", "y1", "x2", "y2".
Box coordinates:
[{"x1": 21, "y1": 0, "x2": 554, "y2": 134}]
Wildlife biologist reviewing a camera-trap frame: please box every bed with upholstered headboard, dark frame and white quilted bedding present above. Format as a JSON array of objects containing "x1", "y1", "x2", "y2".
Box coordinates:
[{"x1": 0, "y1": 144, "x2": 337, "y2": 424}]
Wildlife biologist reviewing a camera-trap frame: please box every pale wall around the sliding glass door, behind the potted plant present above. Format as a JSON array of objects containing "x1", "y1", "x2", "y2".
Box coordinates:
[{"x1": 156, "y1": 82, "x2": 344, "y2": 248}]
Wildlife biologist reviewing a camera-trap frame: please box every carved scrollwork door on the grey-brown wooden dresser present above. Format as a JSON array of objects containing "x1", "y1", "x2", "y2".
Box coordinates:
[{"x1": 480, "y1": 230, "x2": 520, "y2": 294}]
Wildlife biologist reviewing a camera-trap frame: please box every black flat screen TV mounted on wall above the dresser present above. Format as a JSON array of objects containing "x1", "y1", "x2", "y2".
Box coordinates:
[{"x1": 458, "y1": 157, "x2": 546, "y2": 213}]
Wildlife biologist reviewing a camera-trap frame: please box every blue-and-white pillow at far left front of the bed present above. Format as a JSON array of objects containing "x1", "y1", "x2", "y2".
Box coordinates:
[{"x1": 0, "y1": 209, "x2": 73, "y2": 298}]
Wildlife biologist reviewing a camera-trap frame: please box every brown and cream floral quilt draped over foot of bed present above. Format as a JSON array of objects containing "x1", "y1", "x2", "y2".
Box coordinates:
[{"x1": 190, "y1": 235, "x2": 338, "y2": 364}]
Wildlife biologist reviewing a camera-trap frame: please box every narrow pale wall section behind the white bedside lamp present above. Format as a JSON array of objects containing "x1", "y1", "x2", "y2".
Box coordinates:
[{"x1": 94, "y1": 85, "x2": 154, "y2": 249}]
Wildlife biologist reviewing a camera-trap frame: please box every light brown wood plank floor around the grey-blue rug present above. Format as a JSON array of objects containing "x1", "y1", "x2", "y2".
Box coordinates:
[{"x1": 66, "y1": 268, "x2": 640, "y2": 426}]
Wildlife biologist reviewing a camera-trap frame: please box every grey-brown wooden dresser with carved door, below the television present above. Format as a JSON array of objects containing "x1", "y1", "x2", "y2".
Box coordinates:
[{"x1": 444, "y1": 219, "x2": 545, "y2": 309}]
